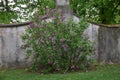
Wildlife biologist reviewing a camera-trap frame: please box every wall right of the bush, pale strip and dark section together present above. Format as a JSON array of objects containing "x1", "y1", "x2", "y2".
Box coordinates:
[{"x1": 84, "y1": 24, "x2": 120, "y2": 64}]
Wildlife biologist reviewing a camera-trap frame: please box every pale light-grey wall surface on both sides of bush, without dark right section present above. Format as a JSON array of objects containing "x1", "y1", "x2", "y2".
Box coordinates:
[{"x1": 0, "y1": 24, "x2": 99, "y2": 68}]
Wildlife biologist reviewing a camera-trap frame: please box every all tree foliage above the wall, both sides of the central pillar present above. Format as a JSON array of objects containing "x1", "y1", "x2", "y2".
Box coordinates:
[{"x1": 0, "y1": 0, "x2": 120, "y2": 24}]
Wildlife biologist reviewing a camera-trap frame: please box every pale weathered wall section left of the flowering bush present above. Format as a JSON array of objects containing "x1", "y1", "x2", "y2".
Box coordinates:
[{"x1": 0, "y1": 26, "x2": 29, "y2": 67}]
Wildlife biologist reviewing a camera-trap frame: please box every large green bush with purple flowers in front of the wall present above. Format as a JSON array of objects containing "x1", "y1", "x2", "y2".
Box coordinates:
[{"x1": 22, "y1": 10, "x2": 93, "y2": 73}]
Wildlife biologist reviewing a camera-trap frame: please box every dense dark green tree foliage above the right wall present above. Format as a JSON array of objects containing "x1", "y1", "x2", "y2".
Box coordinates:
[{"x1": 70, "y1": 0, "x2": 120, "y2": 24}]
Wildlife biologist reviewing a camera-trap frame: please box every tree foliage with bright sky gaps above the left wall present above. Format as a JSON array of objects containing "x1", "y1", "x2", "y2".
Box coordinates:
[{"x1": 0, "y1": 0, "x2": 55, "y2": 23}]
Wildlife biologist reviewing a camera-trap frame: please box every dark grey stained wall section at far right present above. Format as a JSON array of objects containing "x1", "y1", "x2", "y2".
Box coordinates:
[{"x1": 98, "y1": 27, "x2": 120, "y2": 63}]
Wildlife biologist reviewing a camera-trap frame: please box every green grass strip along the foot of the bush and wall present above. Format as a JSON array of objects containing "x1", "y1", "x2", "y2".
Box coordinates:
[{"x1": 0, "y1": 65, "x2": 120, "y2": 80}]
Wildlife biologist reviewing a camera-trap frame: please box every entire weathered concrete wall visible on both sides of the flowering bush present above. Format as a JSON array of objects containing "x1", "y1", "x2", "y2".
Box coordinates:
[{"x1": 0, "y1": 24, "x2": 120, "y2": 68}]
